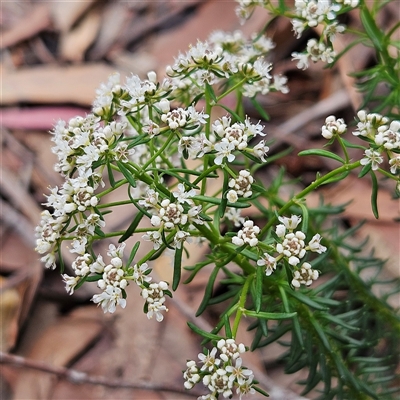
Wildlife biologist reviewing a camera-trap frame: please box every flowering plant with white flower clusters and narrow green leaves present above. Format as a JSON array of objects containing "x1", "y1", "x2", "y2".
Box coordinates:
[{"x1": 37, "y1": 0, "x2": 400, "y2": 400}]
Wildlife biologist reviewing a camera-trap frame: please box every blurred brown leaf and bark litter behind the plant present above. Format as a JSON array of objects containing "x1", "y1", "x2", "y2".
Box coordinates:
[{"x1": 0, "y1": 0, "x2": 399, "y2": 400}]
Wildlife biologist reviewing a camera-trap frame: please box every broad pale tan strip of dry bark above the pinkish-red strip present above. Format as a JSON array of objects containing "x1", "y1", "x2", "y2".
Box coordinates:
[{"x1": 0, "y1": 63, "x2": 122, "y2": 106}]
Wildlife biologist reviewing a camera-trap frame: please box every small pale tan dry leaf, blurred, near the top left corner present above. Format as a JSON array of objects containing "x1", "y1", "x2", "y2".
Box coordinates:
[{"x1": 59, "y1": 8, "x2": 102, "y2": 62}]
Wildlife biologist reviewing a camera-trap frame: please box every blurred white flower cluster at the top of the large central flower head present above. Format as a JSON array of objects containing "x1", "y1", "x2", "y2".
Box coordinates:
[{"x1": 167, "y1": 31, "x2": 288, "y2": 97}]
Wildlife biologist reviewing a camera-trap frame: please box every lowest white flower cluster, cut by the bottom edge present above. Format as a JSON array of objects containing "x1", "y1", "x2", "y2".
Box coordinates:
[{"x1": 183, "y1": 339, "x2": 255, "y2": 400}]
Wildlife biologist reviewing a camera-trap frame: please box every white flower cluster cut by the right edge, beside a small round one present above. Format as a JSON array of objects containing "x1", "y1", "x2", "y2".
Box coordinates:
[{"x1": 353, "y1": 110, "x2": 400, "y2": 175}]
